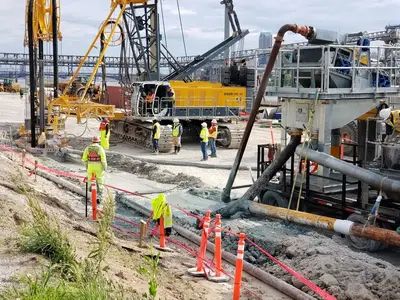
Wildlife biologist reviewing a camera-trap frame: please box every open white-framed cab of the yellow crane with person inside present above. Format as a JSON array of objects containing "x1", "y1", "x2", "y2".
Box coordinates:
[{"x1": 131, "y1": 81, "x2": 173, "y2": 117}]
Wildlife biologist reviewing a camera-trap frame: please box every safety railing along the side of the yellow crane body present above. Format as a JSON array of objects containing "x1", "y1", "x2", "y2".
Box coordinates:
[{"x1": 134, "y1": 97, "x2": 248, "y2": 119}]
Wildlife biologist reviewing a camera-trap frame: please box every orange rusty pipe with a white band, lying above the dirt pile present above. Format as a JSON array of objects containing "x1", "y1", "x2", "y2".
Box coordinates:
[{"x1": 221, "y1": 199, "x2": 400, "y2": 246}]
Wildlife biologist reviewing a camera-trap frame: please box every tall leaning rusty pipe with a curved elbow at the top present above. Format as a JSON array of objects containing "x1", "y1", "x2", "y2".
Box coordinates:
[{"x1": 221, "y1": 24, "x2": 316, "y2": 203}]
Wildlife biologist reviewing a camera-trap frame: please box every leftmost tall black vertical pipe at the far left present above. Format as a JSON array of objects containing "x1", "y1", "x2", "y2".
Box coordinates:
[{"x1": 28, "y1": 0, "x2": 36, "y2": 148}]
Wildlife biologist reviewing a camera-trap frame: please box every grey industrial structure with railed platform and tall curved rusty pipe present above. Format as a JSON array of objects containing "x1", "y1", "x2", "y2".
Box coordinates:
[{"x1": 222, "y1": 25, "x2": 400, "y2": 251}]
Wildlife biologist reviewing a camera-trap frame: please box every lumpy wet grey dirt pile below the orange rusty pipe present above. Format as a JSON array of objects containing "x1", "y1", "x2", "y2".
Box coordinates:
[{"x1": 217, "y1": 220, "x2": 400, "y2": 300}]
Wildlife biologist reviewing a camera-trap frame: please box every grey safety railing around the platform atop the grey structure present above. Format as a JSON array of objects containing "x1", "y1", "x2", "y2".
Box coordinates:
[{"x1": 259, "y1": 45, "x2": 400, "y2": 97}]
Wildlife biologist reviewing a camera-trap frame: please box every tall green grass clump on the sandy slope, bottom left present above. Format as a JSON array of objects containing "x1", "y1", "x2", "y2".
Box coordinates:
[{"x1": 0, "y1": 188, "x2": 142, "y2": 300}]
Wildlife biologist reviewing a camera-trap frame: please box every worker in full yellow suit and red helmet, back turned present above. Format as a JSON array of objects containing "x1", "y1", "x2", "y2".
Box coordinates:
[{"x1": 82, "y1": 136, "x2": 107, "y2": 204}]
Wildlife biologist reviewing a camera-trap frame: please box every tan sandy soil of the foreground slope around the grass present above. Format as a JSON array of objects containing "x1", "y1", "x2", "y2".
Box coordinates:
[{"x1": 0, "y1": 146, "x2": 287, "y2": 300}]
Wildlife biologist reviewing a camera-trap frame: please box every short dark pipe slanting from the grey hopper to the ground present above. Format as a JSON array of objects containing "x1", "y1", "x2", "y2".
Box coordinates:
[{"x1": 242, "y1": 131, "x2": 302, "y2": 200}]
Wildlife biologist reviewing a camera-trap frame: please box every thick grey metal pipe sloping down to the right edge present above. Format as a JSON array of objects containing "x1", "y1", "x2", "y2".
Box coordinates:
[{"x1": 296, "y1": 146, "x2": 400, "y2": 194}]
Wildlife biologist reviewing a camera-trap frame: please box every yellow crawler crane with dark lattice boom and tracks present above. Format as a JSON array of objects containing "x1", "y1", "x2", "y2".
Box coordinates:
[{"x1": 111, "y1": 0, "x2": 254, "y2": 152}]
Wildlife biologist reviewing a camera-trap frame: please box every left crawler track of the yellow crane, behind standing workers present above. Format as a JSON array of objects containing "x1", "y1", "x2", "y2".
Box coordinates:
[{"x1": 111, "y1": 119, "x2": 174, "y2": 153}]
